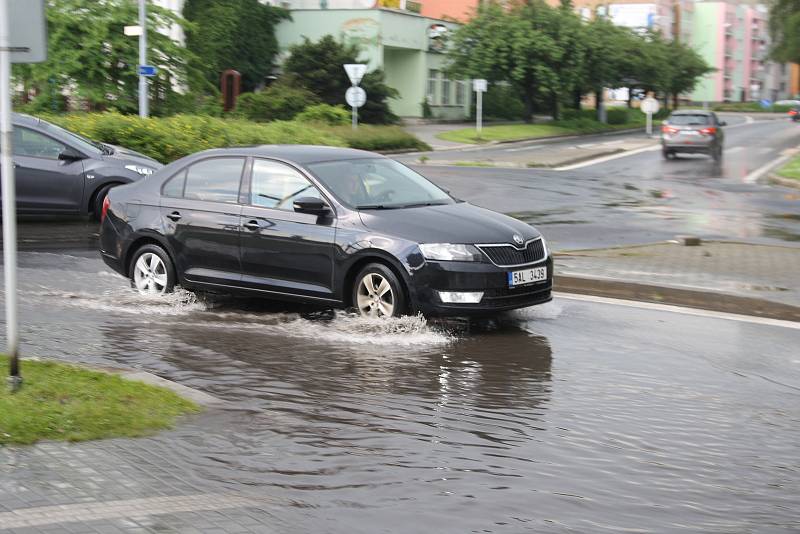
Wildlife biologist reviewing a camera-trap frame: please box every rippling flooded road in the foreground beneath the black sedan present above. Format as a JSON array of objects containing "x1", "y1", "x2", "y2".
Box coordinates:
[{"x1": 1, "y1": 248, "x2": 800, "y2": 533}]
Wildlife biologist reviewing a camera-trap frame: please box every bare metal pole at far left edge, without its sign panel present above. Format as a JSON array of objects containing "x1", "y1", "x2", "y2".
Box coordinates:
[{"x1": 0, "y1": 0, "x2": 22, "y2": 391}]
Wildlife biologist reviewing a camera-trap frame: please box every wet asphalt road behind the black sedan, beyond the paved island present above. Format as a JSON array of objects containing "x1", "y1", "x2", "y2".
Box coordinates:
[{"x1": 404, "y1": 113, "x2": 800, "y2": 250}]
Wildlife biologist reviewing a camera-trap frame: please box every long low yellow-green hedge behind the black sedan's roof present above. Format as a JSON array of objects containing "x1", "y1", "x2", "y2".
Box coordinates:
[{"x1": 42, "y1": 113, "x2": 429, "y2": 163}]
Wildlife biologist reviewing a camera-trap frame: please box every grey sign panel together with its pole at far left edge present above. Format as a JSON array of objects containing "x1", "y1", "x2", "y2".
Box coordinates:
[{"x1": 0, "y1": 0, "x2": 47, "y2": 391}]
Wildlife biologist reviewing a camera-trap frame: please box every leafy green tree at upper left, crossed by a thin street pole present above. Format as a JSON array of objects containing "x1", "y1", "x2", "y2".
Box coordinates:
[{"x1": 14, "y1": 0, "x2": 188, "y2": 112}]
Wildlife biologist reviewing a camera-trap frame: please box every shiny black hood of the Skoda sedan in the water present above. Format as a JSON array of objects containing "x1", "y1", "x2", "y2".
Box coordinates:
[{"x1": 359, "y1": 202, "x2": 541, "y2": 244}]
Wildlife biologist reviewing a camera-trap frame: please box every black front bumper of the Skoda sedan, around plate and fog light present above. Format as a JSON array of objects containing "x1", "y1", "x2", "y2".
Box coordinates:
[{"x1": 409, "y1": 256, "x2": 553, "y2": 316}]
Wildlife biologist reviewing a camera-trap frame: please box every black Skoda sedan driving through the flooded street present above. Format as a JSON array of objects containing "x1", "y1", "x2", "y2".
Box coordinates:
[{"x1": 100, "y1": 145, "x2": 553, "y2": 316}]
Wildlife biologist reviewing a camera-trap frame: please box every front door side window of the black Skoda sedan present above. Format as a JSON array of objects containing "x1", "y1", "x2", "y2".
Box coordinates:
[{"x1": 250, "y1": 159, "x2": 322, "y2": 211}]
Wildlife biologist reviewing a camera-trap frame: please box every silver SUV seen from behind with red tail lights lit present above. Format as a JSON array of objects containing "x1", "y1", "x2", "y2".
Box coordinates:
[{"x1": 661, "y1": 110, "x2": 725, "y2": 161}]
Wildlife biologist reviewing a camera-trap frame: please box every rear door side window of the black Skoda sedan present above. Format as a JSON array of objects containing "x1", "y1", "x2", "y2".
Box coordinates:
[{"x1": 183, "y1": 158, "x2": 244, "y2": 203}]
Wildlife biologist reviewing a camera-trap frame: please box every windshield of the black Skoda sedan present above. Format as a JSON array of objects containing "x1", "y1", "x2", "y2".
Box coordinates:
[{"x1": 308, "y1": 158, "x2": 455, "y2": 209}]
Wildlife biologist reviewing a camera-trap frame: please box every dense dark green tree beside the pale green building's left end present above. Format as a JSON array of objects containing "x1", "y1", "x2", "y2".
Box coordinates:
[{"x1": 183, "y1": 0, "x2": 289, "y2": 91}]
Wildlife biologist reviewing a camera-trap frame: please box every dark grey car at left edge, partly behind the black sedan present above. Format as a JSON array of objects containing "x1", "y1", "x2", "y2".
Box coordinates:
[{"x1": 1, "y1": 113, "x2": 163, "y2": 219}]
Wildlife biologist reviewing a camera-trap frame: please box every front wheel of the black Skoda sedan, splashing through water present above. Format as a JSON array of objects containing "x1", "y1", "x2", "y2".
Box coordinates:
[{"x1": 352, "y1": 263, "x2": 407, "y2": 317}]
